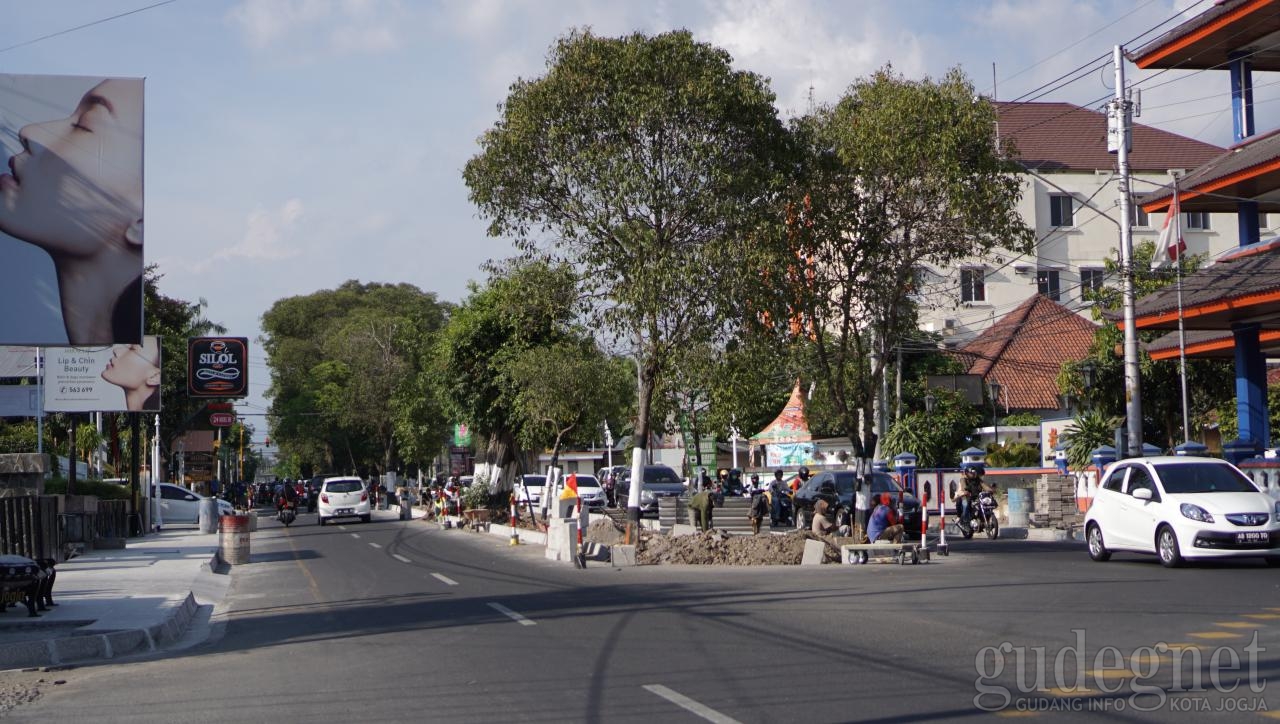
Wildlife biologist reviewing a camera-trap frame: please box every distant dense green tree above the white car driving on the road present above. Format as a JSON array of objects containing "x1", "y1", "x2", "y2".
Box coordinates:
[{"x1": 261, "y1": 280, "x2": 447, "y2": 475}]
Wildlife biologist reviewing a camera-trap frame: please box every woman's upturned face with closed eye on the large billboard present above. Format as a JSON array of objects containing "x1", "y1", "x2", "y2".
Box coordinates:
[{"x1": 0, "y1": 79, "x2": 142, "y2": 256}]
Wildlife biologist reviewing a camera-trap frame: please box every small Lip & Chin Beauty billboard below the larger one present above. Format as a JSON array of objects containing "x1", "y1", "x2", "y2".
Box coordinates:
[{"x1": 45, "y1": 335, "x2": 160, "y2": 412}]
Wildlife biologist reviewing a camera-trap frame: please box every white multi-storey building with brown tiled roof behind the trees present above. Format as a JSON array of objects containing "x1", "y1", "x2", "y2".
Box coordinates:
[{"x1": 916, "y1": 102, "x2": 1254, "y2": 348}]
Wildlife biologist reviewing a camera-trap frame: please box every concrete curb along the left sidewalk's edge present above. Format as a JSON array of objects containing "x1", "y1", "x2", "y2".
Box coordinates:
[{"x1": 0, "y1": 551, "x2": 219, "y2": 670}]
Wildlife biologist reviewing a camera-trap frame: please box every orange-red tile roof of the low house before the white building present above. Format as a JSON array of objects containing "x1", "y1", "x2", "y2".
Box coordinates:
[{"x1": 959, "y1": 294, "x2": 1097, "y2": 409}]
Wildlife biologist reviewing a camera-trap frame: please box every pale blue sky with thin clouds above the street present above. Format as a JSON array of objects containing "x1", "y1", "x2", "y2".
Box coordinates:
[{"x1": 0, "y1": 0, "x2": 1259, "y2": 430}]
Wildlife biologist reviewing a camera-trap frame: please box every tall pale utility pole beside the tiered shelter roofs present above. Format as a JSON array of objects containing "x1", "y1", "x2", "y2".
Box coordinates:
[{"x1": 1107, "y1": 45, "x2": 1142, "y2": 455}]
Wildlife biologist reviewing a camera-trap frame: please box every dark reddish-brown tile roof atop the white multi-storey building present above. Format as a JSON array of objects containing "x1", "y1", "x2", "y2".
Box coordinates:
[{"x1": 996, "y1": 102, "x2": 1222, "y2": 173}]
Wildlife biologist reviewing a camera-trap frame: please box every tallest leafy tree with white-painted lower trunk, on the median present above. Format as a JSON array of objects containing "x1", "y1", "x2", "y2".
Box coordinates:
[{"x1": 463, "y1": 31, "x2": 786, "y2": 527}]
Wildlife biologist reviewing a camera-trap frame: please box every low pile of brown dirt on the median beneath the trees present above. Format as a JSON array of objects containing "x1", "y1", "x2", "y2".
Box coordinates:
[{"x1": 636, "y1": 531, "x2": 840, "y2": 565}]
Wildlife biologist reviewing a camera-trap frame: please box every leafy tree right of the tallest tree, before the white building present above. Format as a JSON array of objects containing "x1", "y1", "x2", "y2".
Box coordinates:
[{"x1": 773, "y1": 68, "x2": 1033, "y2": 465}]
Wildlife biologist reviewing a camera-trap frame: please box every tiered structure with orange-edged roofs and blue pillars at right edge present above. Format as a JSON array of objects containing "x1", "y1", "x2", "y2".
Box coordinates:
[{"x1": 1128, "y1": 0, "x2": 1280, "y2": 453}]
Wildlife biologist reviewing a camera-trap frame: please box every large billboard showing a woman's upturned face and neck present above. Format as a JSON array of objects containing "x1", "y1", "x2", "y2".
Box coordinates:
[{"x1": 0, "y1": 74, "x2": 143, "y2": 347}]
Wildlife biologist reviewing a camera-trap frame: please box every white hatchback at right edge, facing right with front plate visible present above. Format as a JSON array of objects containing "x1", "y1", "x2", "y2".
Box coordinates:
[{"x1": 1084, "y1": 457, "x2": 1280, "y2": 568}]
